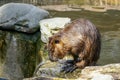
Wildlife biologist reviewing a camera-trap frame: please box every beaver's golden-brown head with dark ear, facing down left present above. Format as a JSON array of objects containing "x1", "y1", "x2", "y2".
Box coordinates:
[{"x1": 47, "y1": 35, "x2": 65, "y2": 61}]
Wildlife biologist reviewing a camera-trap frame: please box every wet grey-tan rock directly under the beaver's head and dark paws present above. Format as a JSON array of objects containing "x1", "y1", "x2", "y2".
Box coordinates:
[{"x1": 34, "y1": 60, "x2": 81, "y2": 79}]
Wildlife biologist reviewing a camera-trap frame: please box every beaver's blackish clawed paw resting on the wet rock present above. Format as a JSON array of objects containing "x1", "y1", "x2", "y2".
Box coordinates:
[{"x1": 61, "y1": 64, "x2": 77, "y2": 73}]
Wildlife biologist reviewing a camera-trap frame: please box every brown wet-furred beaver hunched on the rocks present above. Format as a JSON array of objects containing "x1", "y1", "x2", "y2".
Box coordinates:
[{"x1": 47, "y1": 18, "x2": 101, "y2": 72}]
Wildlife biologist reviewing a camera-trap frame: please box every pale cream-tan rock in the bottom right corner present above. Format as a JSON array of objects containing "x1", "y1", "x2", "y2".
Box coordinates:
[{"x1": 81, "y1": 63, "x2": 120, "y2": 80}]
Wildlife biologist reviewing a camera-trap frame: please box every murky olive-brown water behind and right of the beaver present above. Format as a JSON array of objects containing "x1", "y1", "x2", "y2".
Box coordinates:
[{"x1": 50, "y1": 10, "x2": 120, "y2": 65}]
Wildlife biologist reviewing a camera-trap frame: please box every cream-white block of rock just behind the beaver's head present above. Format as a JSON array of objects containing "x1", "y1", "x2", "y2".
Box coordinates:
[{"x1": 39, "y1": 17, "x2": 71, "y2": 43}]
